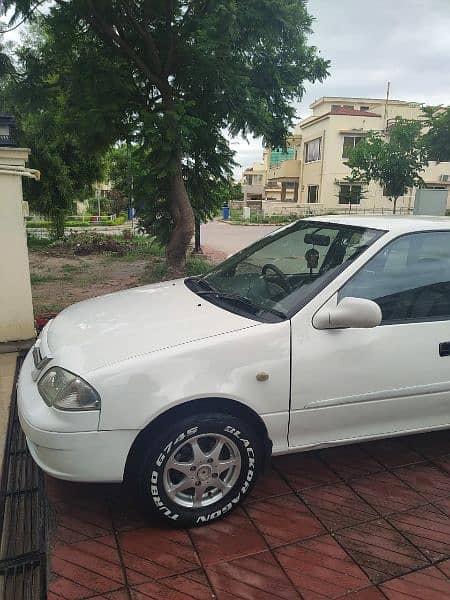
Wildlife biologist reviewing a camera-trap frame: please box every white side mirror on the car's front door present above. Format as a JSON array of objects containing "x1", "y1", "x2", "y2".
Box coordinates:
[{"x1": 313, "y1": 297, "x2": 382, "y2": 329}]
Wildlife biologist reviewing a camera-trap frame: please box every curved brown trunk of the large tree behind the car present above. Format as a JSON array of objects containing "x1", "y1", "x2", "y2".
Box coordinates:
[{"x1": 167, "y1": 160, "x2": 195, "y2": 274}]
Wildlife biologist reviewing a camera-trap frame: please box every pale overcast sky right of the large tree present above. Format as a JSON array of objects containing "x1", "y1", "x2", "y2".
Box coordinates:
[{"x1": 232, "y1": 0, "x2": 450, "y2": 177}]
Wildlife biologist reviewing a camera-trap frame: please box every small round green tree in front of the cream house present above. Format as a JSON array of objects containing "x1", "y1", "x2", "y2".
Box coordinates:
[{"x1": 347, "y1": 117, "x2": 428, "y2": 214}]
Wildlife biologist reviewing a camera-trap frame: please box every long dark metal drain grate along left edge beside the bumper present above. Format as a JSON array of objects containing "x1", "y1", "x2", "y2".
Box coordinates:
[{"x1": 0, "y1": 357, "x2": 47, "y2": 600}]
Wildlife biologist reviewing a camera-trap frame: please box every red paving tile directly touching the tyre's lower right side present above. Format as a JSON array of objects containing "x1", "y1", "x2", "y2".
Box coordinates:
[{"x1": 191, "y1": 508, "x2": 267, "y2": 565}]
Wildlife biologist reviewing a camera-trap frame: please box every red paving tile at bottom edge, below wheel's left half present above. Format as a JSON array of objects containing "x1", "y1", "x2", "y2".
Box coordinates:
[{"x1": 131, "y1": 571, "x2": 214, "y2": 600}]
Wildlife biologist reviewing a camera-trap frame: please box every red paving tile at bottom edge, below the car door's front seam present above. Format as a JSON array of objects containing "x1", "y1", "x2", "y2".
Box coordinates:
[{"x1": 275, "y1": 535, "x2": 370, "y2": 600}]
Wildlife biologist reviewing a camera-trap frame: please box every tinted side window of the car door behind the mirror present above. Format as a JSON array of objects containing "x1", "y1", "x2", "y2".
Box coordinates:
[{"x1": 339, "y1": 231, "x2": 450, "y2": 323}]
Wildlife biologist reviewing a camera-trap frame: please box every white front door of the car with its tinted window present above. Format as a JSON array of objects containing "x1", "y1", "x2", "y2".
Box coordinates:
[{"x1": 289, "y1": 231, "x2": 450, "y2": 447}]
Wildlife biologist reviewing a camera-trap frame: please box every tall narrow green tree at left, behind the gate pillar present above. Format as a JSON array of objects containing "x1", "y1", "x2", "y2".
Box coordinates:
[{"x1": 2, "y1": 23, "x2": 119, "y2": 237}]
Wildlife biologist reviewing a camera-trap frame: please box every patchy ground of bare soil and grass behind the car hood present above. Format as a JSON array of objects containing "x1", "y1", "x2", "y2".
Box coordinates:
[{"x1": 28, "y1": 234, "x2": 212, "y2": 316}]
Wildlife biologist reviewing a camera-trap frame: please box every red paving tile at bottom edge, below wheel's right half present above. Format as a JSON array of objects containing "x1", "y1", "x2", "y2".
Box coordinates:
[{"x1": 207, "y1": 552, "x2": 300, "y2": 600}]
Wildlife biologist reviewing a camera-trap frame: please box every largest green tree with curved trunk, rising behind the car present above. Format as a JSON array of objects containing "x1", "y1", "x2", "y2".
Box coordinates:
[{"x1": 3, "y1": 0, "x2": 328, "y2": 269}]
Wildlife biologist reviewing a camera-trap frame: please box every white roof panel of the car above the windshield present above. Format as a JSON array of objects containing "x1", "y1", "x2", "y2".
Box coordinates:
[{"x1": 307, "y1": 215, "x2": 450, "y2": 233}]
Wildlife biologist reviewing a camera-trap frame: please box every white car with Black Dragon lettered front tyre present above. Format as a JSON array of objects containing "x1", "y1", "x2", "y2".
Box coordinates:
[{"x1": 18, "y1": 216, "x2": 450, "y2": 526}]
